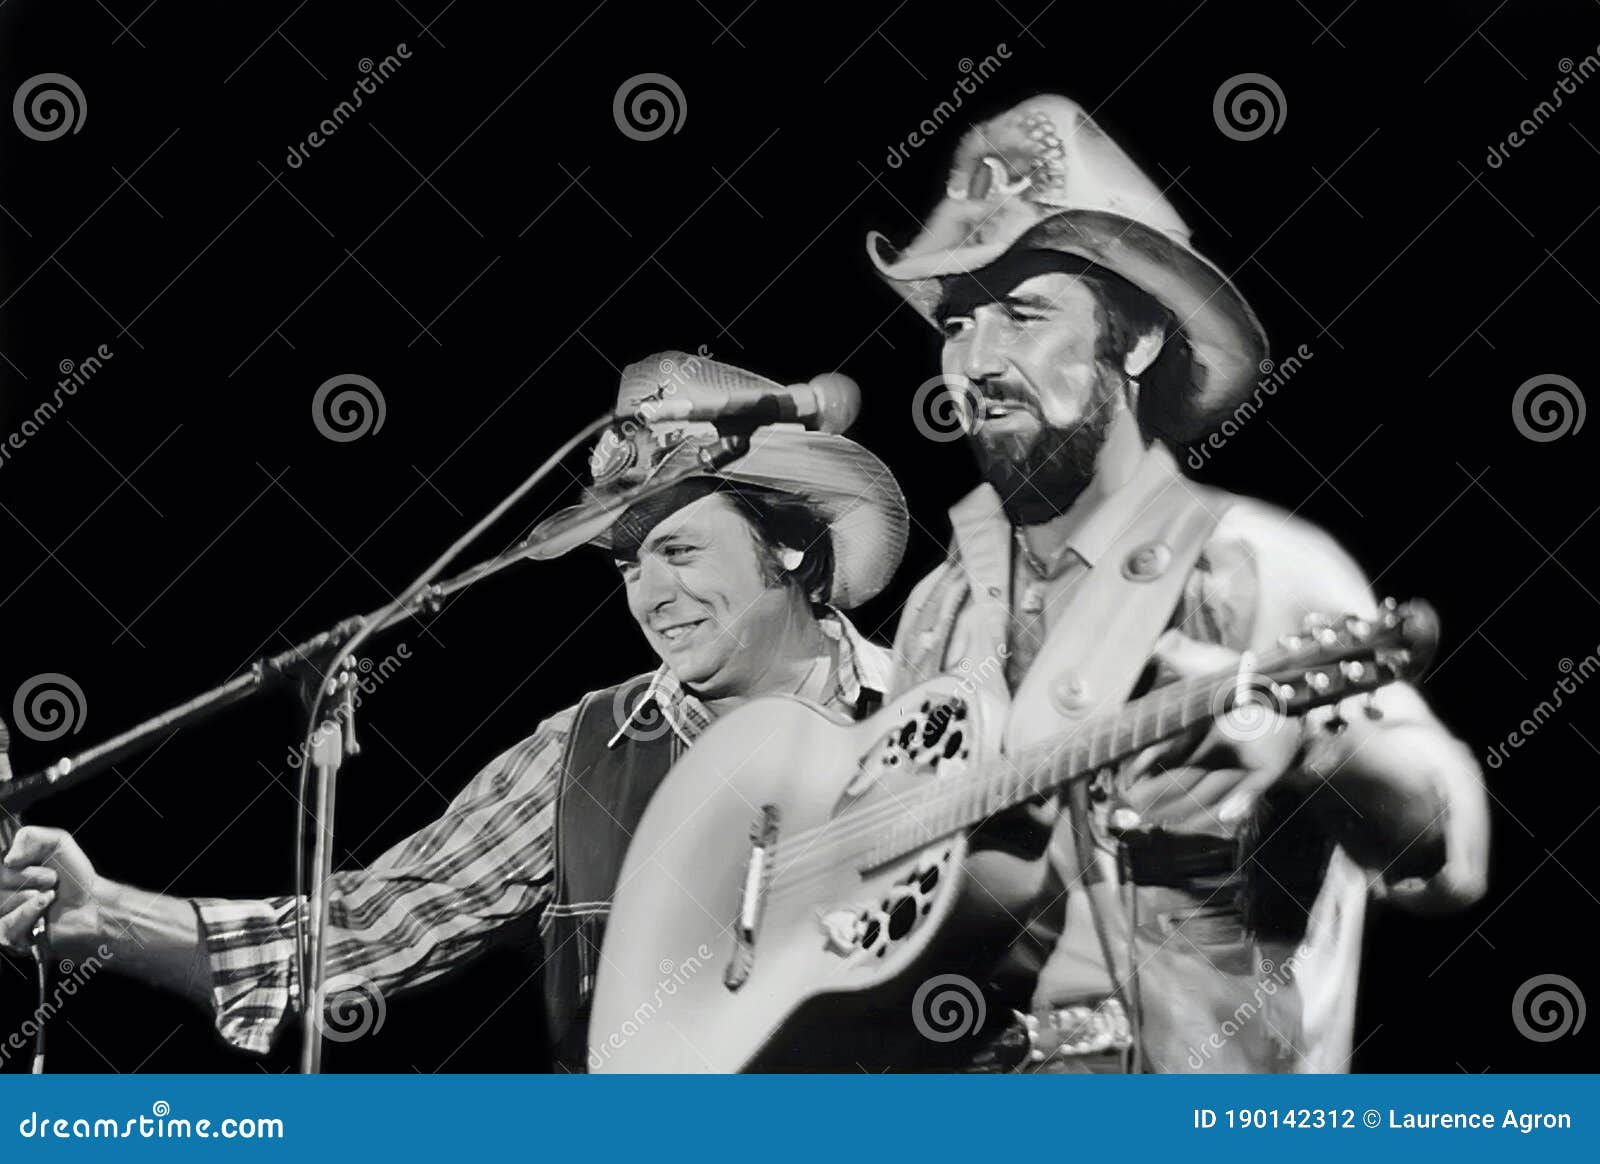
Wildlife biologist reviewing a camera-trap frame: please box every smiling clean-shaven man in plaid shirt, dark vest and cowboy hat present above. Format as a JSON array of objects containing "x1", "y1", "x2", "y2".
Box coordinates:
[{"x1": 0, "y1": 353, "x2": 907, "y2": 1071}]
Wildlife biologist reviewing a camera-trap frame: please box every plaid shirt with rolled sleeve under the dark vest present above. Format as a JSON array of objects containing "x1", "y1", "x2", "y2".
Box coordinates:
[{"x1": 194, "y1": 611, "x2": 890, "y2": 1054}]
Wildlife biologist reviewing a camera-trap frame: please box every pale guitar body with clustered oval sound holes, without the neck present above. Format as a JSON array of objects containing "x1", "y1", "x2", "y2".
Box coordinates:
[{"x1": 589, "y1": 678, "x2": 1048, "y2": 1073}]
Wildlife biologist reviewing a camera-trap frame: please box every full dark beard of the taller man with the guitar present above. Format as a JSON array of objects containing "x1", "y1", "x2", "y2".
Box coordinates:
[{"x1": 968, "y1": 374, "x2": 1117, "y2": 526}]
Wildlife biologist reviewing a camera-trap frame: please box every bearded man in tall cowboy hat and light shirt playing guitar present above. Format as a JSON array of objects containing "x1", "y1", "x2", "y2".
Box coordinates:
[{"x1": 869, "y1": 96, "x2": 1488, "y2": 1071}]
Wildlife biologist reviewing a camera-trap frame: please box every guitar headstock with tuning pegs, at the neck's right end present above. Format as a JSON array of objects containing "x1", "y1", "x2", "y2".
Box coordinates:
[{"x1": 1248, "y1": 598, "x2": 1438, "y2": 715}]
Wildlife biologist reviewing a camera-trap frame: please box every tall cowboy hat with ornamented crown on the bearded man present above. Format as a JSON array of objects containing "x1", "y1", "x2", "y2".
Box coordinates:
[{"x1": 867, "y1": 94, "x2": 1267, "y2": 440}]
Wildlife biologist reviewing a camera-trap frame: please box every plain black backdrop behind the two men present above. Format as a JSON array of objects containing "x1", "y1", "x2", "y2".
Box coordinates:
[{"x1": 0, "y1": 0, "x2": 1600, "y2": 1071}]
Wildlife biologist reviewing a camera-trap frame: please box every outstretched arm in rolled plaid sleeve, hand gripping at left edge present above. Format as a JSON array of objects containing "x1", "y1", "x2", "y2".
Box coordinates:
[{"x1": 0, "y1": 712, "x2": 571, "y2": 1052}]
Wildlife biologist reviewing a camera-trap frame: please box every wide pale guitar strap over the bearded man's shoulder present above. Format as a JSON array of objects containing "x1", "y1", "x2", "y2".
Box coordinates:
[{"x1": 1005, "y1": 472, "x2": 1229, "y2": 1046}]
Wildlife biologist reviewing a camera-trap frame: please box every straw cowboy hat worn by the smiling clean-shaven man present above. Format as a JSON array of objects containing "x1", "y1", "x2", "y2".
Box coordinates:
[{"x1": 533, "y1": 352, "x2": 910, "y2": 609}]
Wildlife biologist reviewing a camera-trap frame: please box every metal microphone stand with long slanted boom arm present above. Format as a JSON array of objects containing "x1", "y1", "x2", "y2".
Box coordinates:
[{"x1": 0, "y1": 413, "x2": 758, "y2": 1073}]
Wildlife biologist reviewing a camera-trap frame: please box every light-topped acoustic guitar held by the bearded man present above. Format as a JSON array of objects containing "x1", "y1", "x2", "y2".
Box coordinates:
[{"x1": 589, "y1": 600, "x2": 1437, "y2": 1073}]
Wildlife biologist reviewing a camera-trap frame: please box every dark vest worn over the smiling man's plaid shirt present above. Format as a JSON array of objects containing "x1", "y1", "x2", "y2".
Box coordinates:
[{"x1": 539, "y1": 675, "x2": 683, "y2": 1071}]
